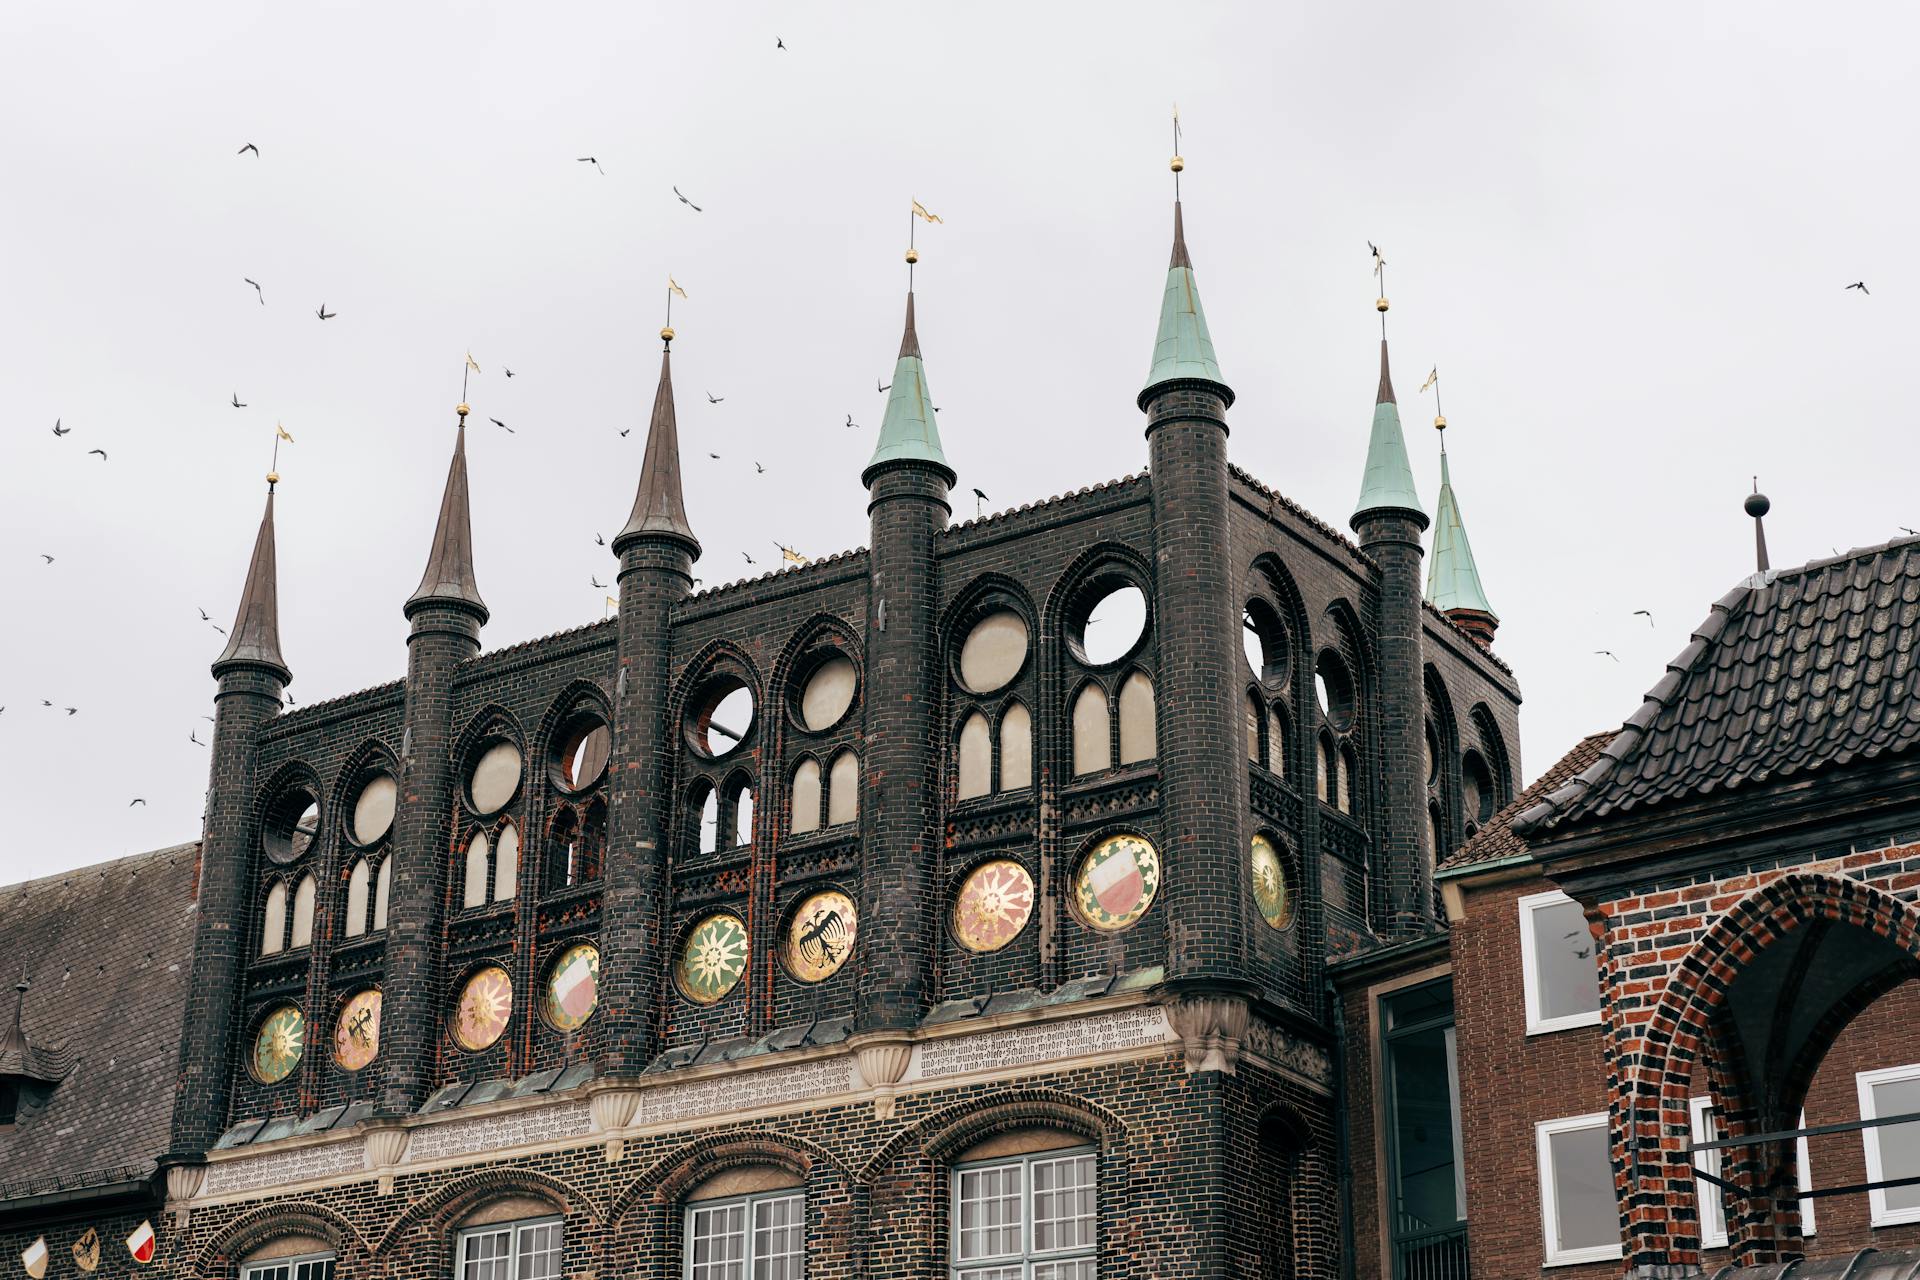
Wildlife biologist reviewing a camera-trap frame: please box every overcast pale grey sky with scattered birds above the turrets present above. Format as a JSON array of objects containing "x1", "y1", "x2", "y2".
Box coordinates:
[{"x1": 0, "y1": 0, "x2": 1920, "y2": 881}]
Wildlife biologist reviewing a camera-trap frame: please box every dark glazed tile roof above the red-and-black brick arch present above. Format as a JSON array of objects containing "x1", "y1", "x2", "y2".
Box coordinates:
[{"x1": 1513, "y1": 539, "x2": 1920, "y2": 837}]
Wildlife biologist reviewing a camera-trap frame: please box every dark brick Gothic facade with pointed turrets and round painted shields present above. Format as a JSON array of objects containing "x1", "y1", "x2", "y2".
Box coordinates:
[{"x1": 0, "y1": 202, "x2": 1519, "y2": 1280}]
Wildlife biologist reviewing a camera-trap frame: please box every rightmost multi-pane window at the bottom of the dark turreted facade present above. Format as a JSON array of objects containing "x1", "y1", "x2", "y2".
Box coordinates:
[{"x1": 950, "y1": 1148, "x2": 1100, "y2": 1280}]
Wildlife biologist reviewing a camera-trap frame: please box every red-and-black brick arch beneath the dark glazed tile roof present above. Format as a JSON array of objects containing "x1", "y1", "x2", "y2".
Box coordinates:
[{"x1": 1607, "y1": 871, "x2": 1920, "y2": 1267}]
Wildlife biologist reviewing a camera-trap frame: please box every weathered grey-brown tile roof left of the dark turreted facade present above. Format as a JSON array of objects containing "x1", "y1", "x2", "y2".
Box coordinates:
[{"x1": 0, "y1": 844, "x2": 200, "y2": 1201}]
